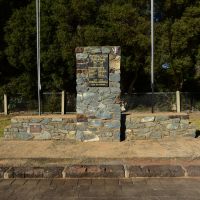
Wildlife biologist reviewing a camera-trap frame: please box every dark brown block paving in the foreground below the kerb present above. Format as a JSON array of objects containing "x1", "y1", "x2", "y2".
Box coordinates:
[{"x1": 0, "y1": 178, "x2": 200, "y2": 200}]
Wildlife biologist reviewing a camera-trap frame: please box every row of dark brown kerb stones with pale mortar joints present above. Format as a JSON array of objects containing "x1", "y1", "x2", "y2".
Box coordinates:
[{"x1": 0, "y1": 165, "x2": 200, "y2": 179}]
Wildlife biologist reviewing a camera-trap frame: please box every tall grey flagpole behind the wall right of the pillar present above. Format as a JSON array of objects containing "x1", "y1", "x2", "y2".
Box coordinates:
[{"x1": 151, "y1": 0, "x2": 154, "y2": 113}]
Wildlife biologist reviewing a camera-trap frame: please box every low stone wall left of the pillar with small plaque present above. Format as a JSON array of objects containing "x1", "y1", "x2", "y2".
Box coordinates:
[{"x1": 4, "y1": 115, "x2": 77, "y2": 140}]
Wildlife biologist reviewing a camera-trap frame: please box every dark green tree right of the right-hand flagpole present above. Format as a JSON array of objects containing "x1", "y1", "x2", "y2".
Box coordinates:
[{"x1": 155, "y1": 1, "x2": 200, "y2": 91}]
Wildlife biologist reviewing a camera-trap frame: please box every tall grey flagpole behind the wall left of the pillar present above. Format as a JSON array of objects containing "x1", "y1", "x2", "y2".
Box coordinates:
[{"x1": 36, "y1": 0, "x2": 41, "y2": 115}]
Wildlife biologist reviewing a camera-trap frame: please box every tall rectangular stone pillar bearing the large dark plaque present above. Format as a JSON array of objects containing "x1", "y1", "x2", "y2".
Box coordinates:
[{"x1": 76, "y1": 46, "x2": 121, "y2": 141}]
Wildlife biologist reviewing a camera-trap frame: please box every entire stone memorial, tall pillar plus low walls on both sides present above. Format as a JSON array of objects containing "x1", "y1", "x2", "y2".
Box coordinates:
[{"x1": 4, "y1": 46, "x2": 196, "y2": 141}]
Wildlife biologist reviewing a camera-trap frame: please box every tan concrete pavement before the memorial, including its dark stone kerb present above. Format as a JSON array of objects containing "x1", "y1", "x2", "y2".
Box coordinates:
[{"x1": 0, "y1": 138, "x2": 200, "y2": 178}]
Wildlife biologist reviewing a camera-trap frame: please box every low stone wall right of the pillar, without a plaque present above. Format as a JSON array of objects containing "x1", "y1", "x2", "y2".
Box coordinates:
[{"x1": 123, "y1": 113, "x2": 196, "y2": 141}]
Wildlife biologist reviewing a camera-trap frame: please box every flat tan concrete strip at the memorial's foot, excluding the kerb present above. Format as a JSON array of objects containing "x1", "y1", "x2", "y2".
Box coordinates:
[{"x1": 0, "y1": 137, "x2": 200, "y2": 160}]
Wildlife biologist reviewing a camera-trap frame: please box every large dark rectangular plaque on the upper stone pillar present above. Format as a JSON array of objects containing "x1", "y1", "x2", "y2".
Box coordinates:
[{"x1": 88, "y1": 54, "x2": 109, "y2": 87}]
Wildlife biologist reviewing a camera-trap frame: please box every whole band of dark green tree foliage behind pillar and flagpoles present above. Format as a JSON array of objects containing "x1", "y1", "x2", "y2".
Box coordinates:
[{"x1": 0, "y1": 0, "x2": 200, "y2": 96}]
